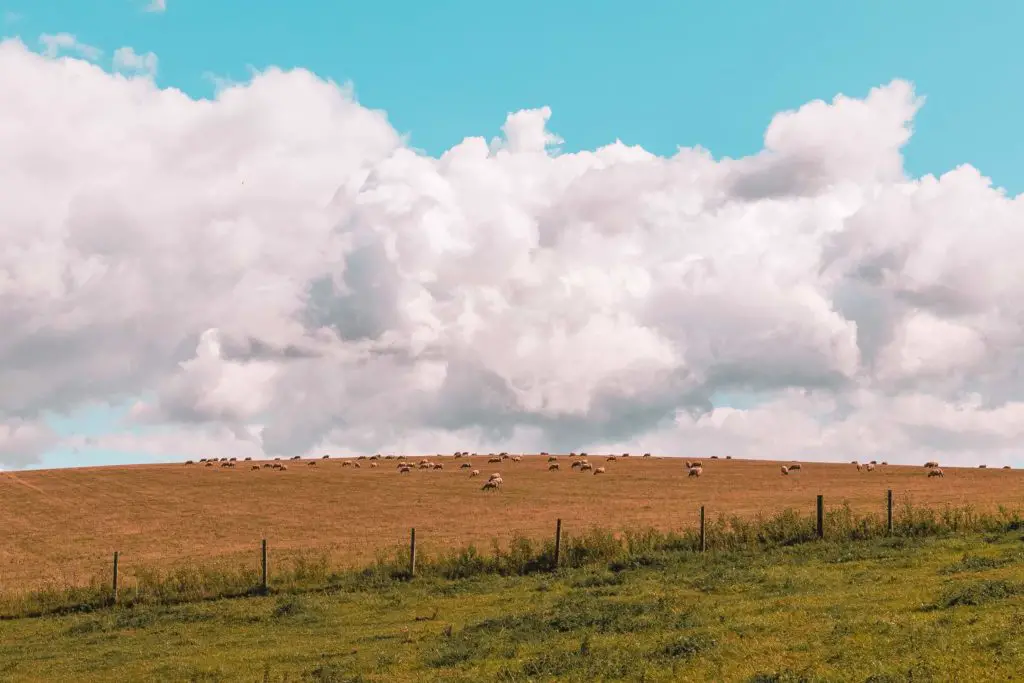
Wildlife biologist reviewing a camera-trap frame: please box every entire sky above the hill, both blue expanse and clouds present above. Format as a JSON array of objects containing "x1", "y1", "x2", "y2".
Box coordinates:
[{"x1": 0, "y1": 0, "x2": 1024, "y2": 469}]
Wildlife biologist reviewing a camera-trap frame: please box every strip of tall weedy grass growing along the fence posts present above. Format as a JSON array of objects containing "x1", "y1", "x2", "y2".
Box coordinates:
[{"x1": 0, "y1": 500, "x2": 1024, "y2": 618}]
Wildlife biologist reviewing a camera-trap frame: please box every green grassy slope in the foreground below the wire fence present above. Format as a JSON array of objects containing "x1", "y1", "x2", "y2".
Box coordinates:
[{"x1": 0, "y1": 505, "x2": 1024, "y2": 682}]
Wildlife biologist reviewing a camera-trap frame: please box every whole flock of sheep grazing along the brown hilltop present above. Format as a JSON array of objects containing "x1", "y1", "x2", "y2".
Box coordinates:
[{"x1": 185, "y1": 452, "x2": 1010, "y2": 490}]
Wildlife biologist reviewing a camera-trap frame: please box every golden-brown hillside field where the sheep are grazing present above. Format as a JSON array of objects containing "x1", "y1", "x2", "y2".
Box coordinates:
[{"x1": 0, "y1": 456, "x2": 1024, "y2": 592}]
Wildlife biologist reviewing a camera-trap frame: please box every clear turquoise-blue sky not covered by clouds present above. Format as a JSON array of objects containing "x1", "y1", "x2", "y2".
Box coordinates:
[{"x1": 0, "y1": 0, "x2": 1024, "y2": 466}]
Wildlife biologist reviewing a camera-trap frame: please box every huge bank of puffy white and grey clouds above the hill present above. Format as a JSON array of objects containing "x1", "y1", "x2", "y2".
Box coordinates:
[{"x1": 0, "y1": 41, "x2": 1024, "y2": 465}]
